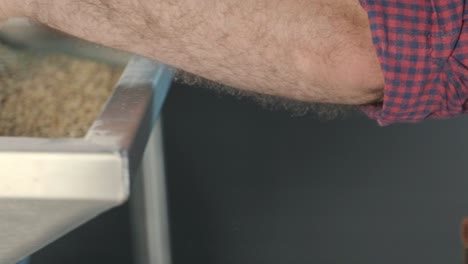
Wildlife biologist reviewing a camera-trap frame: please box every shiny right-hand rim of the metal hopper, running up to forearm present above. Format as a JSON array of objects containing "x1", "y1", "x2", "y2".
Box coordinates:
[{"x1": 86, "y1": 57, "x2": 173, "y2": 173}]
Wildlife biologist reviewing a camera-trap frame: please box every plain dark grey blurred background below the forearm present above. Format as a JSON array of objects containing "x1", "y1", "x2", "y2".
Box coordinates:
[{"x1": 26, "y1": 81, "x2": 468, "y2": 264}]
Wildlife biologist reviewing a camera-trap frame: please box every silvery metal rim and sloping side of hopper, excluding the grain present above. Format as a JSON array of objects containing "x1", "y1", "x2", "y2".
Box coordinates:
[{"x1": 0, "y1": 19, "x2": 172, "y2": 264}]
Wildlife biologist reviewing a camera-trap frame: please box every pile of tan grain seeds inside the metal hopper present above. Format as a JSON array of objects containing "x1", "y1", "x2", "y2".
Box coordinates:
[{"x1": 0, "y1": 42, "x2": 123, "y2": 138}]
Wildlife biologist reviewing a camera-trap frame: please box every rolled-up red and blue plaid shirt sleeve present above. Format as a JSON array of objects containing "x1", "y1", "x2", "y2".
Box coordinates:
[{"x1": 360, "y1": 0, "x2": 468, "y2": 125}]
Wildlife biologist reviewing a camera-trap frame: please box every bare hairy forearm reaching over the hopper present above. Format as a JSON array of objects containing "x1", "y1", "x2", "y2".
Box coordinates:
[{"x1": 0, "y1": 0, "x2": 383, "y2": 105}]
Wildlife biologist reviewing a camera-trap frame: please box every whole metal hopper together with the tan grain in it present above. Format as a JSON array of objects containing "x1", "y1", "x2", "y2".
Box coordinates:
[{"x1": 0, "y1": 21, "x2": 172, "y2": 263}]
